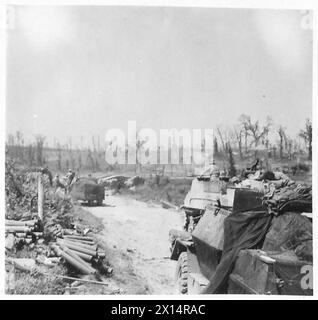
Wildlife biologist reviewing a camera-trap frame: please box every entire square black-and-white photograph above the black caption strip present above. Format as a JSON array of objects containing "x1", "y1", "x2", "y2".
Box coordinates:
[{"x1": 1, "y1": 1, "x2": 317, "y2": 298}]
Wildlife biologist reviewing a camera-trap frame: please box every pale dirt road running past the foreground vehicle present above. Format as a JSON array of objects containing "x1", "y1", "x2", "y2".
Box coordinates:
[{"x1": 87, "y1": 196, "x2": 182, "y2": 294}]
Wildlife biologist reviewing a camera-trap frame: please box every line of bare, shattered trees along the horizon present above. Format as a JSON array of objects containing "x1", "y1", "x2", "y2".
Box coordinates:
[{"x1": 6, "y1": 114, "x2": 312, "y2": 171}]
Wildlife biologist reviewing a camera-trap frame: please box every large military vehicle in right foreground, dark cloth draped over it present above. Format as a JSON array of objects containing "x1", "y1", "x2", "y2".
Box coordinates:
[{"x1": 171, "y1": 188, "x2": 313, "y2": 295}]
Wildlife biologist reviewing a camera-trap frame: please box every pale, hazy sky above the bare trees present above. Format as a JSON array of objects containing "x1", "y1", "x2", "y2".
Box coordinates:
[{"x1": 6, "y1": 6, "x2": 312, "y2": 148}]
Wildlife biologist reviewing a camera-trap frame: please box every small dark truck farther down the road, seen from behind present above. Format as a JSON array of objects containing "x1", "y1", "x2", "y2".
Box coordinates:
[{"x1": 70, "y1": 177, "x2": 105, "y2": 206}]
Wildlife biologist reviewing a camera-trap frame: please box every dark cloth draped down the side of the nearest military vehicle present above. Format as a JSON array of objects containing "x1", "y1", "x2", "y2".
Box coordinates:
[{"x1": 204, "y1": 206, "x2": 272, "y2": 293}]
